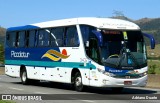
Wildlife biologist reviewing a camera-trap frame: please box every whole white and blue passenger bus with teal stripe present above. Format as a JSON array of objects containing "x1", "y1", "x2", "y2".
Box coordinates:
[{"x1": 5, "y1": 17, "x2": 155, "y2": 91}]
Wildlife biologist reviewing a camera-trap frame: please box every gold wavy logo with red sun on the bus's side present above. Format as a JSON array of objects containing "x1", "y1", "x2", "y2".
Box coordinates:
[{"x1": 41, "y1": 49, "x2": 70, "y2": 61}]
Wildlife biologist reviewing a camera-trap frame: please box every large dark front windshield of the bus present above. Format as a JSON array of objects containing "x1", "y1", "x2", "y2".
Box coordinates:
[{"x1": 100, "y1": 29, "x2": 147, "y2": 69}]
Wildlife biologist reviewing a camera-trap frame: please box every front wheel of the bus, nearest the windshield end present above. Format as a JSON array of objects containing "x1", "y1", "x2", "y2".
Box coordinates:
[{"x1": 74, "y1": 72, "x2": 84, "y2": 92}]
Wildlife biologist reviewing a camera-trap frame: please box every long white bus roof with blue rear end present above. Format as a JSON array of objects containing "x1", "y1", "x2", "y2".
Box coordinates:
[{"x1": 7, "y1": 17, "x2": 140, "y2": 31}]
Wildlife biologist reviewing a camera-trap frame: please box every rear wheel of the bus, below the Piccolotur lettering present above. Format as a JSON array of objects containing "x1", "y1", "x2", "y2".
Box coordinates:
[{"x1": 20, "y1": 68, "x2": 30, "y2": 85}]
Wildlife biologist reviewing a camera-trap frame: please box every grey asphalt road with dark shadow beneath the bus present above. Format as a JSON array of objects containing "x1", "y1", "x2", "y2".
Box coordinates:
[{"x1": 0, "y1": 75, "x2": 160, "y2": 103}]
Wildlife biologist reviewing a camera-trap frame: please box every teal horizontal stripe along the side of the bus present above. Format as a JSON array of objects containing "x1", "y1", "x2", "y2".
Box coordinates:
[{"x1": 5, "y1": 60, "x2": 96, "y2": 69}]
